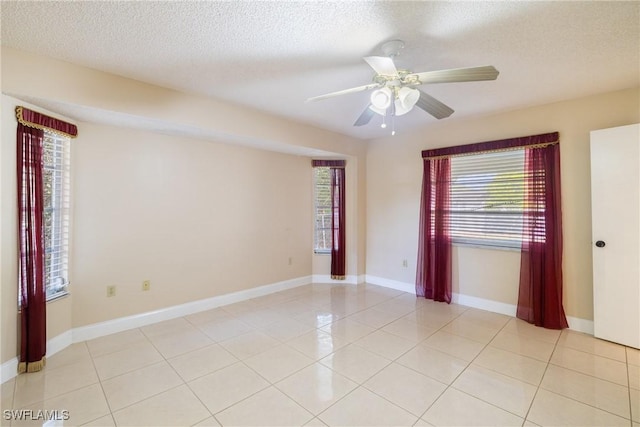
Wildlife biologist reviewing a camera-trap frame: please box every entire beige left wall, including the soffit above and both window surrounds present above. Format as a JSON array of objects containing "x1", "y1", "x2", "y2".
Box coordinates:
[{"x1": 0, "y1": 48, "x2": 366, "y2": 363}]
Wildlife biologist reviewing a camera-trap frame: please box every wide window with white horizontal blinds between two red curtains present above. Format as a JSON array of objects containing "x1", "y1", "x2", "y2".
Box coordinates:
[{"x1": 450, "y1": 149, "x2": 524, "y2": 248}]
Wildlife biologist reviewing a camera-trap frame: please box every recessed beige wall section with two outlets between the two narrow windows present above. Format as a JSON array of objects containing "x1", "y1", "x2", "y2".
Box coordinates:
[{"x1": 71, "y1": 123, "x2": 312, "y2": 326}]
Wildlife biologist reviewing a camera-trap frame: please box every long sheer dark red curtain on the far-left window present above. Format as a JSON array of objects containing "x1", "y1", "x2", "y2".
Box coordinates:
[{"x1": 17, "y1": 123, "x2": 47, "y2": 372}]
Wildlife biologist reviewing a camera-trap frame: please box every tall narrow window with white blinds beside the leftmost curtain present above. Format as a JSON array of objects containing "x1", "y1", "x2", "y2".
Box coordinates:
[{"x1": 43, "y1": 131, "x2": 70, "y2": 300}]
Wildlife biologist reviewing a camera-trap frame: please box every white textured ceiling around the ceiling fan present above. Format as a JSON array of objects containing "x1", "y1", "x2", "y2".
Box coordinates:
[{"x1": 1, "y1": 0, "x2": 640, "y2": 139}]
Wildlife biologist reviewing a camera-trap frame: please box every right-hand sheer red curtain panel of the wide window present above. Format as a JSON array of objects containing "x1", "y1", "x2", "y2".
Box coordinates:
[{"x1": 516, "y1": 144, "x2": 568, "y2": 329}]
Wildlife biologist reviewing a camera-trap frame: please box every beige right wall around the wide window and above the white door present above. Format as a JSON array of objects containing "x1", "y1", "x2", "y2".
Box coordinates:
[{"x1": 366, "y1": 88, "x2": 640, "y2": 319}]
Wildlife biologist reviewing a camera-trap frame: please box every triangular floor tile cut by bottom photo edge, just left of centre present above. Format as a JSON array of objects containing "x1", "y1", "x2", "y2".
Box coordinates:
[{"x1": 216, "y1": 387, "x2": 313, "y2": 426}]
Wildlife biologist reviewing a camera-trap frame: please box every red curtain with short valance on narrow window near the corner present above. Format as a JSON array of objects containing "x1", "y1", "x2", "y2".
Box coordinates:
[{"x1": 311, "y1": 160, "x2": 347, "y2": 280}]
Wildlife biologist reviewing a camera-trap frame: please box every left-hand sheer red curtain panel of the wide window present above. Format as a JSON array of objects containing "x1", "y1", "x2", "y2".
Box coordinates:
[{"x1": 416, "y1": 157, "x2": 451, "y2": 303}]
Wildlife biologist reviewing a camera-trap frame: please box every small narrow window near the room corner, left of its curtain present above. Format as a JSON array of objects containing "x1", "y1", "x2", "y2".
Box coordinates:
[{"x1": 313, "y1": 166, "x2": 331, "y2": 254}]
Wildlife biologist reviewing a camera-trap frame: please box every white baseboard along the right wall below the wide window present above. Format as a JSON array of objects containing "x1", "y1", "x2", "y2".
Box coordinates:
[{"x1": 367, "y1": 274, "x2": 593, "y2": 335}]
